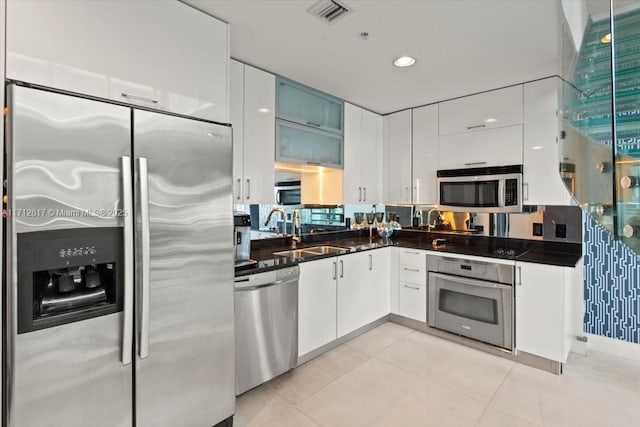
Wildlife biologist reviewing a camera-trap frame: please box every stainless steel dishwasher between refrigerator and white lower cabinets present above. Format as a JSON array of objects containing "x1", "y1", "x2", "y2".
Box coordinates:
[{"x1": 235, "y1": 266, "x2": 300, "y2": 395}]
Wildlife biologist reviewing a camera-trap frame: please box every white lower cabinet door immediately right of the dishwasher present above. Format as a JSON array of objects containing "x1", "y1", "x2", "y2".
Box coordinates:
[{"x1": 298, "y1": 258, "x2": 338, "y2": 356}]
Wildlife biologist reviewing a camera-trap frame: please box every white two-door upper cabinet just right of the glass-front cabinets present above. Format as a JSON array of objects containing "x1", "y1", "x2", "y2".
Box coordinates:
[{"x1": 344, "y1": 103, "x2": 382, "y2": 203}]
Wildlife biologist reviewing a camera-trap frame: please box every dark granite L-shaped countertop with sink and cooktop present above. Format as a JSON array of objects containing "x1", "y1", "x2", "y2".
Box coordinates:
[{"x1": 236, "y1": 230, "x2": 582, "y2": 277}]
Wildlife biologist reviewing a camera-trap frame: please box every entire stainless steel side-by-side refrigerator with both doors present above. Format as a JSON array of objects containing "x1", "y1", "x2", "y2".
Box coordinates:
[{"x1": 3, "y1": 83, "x2": 235, "y2": 427}]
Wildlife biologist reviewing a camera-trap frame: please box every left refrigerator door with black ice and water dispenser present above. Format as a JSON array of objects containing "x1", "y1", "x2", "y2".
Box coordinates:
[{"x1": 4, "y1": 85, "x2": 132, "y2": 427}]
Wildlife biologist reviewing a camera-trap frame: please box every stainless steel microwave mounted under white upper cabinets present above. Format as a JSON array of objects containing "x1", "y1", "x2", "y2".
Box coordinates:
[{"x1": 438, "y1": 165, "x2": 522, "y2": 212}]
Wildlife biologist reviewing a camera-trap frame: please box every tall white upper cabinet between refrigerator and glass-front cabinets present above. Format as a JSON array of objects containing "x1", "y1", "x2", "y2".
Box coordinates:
[{"x1": 229, "y1": 61, "x2": 276, "y2": 204}]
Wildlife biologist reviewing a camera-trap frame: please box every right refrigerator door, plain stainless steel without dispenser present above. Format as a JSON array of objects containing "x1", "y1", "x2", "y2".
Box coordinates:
[{"x1": 134, "y1": 110, "x2": 235, "y2": 427}]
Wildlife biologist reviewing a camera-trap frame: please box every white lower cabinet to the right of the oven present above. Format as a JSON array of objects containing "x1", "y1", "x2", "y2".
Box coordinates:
[{"x1": 515, "y1": 262, "x2": 578, "y2": 363}]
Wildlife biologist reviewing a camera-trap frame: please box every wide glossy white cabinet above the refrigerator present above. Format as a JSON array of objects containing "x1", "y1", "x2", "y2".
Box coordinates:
[{"x1": 7, "y1": 0, "x2": 229, "y2": 123}]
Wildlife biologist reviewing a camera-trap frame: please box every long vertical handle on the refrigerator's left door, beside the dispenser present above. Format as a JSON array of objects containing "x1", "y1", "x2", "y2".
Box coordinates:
[{"x1": 120, "y1": 156, "x2": 134, "y2": 365}]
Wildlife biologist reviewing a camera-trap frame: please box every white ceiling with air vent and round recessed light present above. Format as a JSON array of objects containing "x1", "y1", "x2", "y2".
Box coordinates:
[{"x1": 183, "y1": 0, "x2": 559, "y2": 114}]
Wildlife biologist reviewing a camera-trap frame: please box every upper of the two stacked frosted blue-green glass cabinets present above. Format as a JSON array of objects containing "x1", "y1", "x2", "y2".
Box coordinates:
[{"x1": 276, "y1": 77, "x2": 344, "y2": 135}]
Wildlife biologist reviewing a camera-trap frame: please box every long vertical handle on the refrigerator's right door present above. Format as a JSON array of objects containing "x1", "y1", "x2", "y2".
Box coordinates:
[{"x1": 138, "y1": 157, "x2": 151, "y2": 359}]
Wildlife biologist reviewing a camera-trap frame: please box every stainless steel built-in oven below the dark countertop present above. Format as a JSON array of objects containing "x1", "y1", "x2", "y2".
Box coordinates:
[{"x1": 427, "y1": 256, "x2": 515, "y2": 350}]
